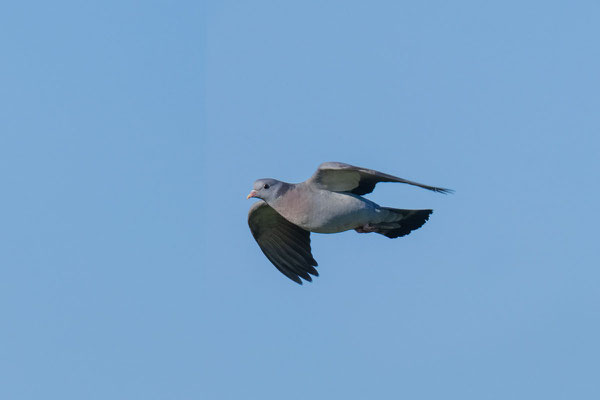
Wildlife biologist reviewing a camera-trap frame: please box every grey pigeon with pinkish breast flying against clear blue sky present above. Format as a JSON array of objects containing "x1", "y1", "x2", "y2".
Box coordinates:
[{"x1": 246, "y1": 162, "x2": 453, "y2": 285}]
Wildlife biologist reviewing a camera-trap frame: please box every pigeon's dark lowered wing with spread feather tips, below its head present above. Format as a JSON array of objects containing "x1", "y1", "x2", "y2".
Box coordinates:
[{"x1": 248, "y1": 200, "x2": 319, "y2": 284}]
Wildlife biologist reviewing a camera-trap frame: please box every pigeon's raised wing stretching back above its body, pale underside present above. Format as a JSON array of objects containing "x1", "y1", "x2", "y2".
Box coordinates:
[{"x1": 307, "y1": 162, "x2": 452, "y2": 195}]
